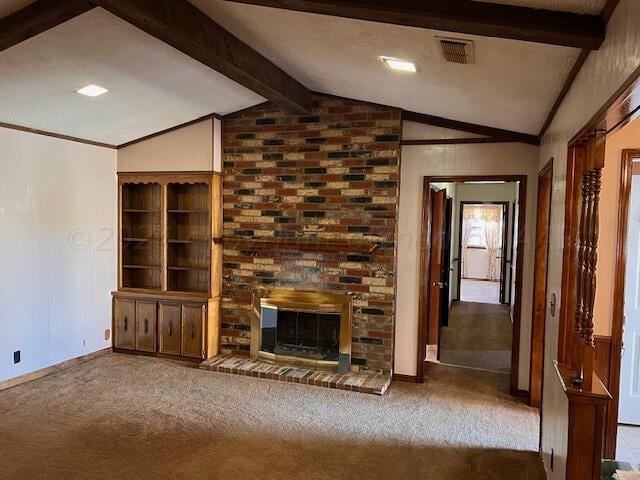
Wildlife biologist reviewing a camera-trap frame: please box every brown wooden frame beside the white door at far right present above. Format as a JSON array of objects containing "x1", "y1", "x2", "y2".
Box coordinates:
[{"x1": 604, "y1": 149, "x2": 640, "y2": 458}]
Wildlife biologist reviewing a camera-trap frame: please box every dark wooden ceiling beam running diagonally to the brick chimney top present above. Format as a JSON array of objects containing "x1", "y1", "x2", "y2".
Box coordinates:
[{"x1": 91, "y1": 0, "x2": 311, "y2": 115}]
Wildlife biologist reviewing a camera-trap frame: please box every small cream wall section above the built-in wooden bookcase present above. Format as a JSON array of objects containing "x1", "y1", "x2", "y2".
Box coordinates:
[{"x1": 118, "y1": 118, "x2": 222, "y2": 172}]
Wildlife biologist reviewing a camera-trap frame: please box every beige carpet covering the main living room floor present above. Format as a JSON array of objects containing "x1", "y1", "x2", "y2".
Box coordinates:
[{"x1": 0, "y1": 354, "x2": 544, "y2": 480}]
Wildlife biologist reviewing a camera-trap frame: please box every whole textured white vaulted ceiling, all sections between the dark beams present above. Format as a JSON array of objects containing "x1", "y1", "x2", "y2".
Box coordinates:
[{"x1": 0, "y1": 0, "x2": 605, "y2": 145}]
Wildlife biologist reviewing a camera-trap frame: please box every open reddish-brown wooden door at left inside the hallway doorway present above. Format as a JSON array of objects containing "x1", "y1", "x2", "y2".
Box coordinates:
[{"x1": 428, "y1": 190, "x2": 447, "y2": 345}]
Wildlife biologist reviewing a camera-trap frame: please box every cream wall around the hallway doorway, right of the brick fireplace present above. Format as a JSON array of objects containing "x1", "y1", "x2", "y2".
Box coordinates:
[{"x1": 394, "y1": 122, "x2": 539, "y2": 389}]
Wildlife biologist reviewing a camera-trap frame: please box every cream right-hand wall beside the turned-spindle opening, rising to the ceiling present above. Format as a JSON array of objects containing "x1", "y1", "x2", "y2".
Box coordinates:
[{"x1": 539, "y1": 0, "x2": 640, "y2": 480}]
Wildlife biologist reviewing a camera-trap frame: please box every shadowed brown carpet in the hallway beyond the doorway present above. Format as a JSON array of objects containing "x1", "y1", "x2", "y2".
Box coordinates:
[{"x1": 440, "y1": 302, "x2": 513, "y2": 373}]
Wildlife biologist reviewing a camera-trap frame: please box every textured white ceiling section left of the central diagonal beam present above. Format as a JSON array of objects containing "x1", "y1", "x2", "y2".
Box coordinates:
[{"x1": 0, "y1": 7, "x2": 264, "y2": 145}]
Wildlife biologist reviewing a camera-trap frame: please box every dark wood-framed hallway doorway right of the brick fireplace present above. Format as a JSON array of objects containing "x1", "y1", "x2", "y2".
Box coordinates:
[{"x1": 417, "y1": 175, "x2": 526, "y2": 394}]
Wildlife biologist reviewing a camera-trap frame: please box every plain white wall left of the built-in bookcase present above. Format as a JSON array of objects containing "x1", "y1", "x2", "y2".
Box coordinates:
[{"x1": 0, "y1": 128, "x2": 117, "y2": 381}]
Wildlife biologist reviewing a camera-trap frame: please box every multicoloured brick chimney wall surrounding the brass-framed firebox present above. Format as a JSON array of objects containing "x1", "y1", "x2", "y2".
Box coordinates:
[{"x1": 222, "y1": 95, "x2": 401, "y2": 374}]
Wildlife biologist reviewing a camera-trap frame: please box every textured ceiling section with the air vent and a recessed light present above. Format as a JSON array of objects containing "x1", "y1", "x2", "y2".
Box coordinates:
[{"x1": 190, "y1": 0, "x2": 578, "y2": 134}]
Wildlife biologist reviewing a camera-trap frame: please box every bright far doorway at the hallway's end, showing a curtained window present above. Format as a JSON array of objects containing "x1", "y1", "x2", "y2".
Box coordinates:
[{"x1": 458, "y1": 201, "x2": 509, "y2": 304}]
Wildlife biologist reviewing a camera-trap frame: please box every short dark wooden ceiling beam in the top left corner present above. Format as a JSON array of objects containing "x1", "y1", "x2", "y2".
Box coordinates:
[{"x1": 0, "y1": 0, "x2": 95, "y2": 52}]
